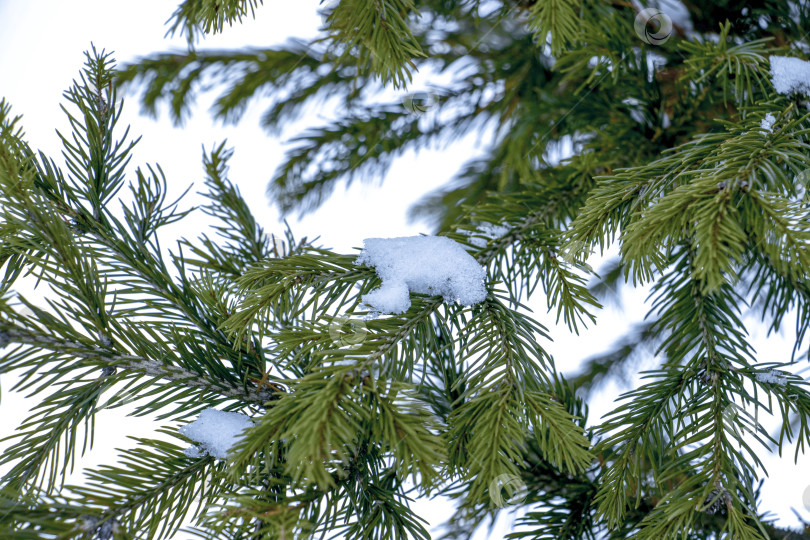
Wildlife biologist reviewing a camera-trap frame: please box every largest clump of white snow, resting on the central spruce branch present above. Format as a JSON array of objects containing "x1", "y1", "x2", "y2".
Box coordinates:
[{"x1": 357, "y1": 236, "x2": 487, "y2": 314}]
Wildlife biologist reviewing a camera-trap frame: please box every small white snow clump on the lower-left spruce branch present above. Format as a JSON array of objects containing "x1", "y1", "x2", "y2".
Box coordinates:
[{"x1": 180, "y1": 409, "x2": 253, "y2": 459}]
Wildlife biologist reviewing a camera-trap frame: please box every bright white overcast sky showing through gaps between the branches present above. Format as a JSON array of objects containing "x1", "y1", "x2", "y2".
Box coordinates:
[{"x1": 0, "y1": 0, "x2": 810, "y2": 539}]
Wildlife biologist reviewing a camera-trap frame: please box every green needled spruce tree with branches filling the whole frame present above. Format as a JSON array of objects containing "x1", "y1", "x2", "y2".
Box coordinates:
[{"x1": 0, "y1": 0, "x2": 810, "y2": 539}]
